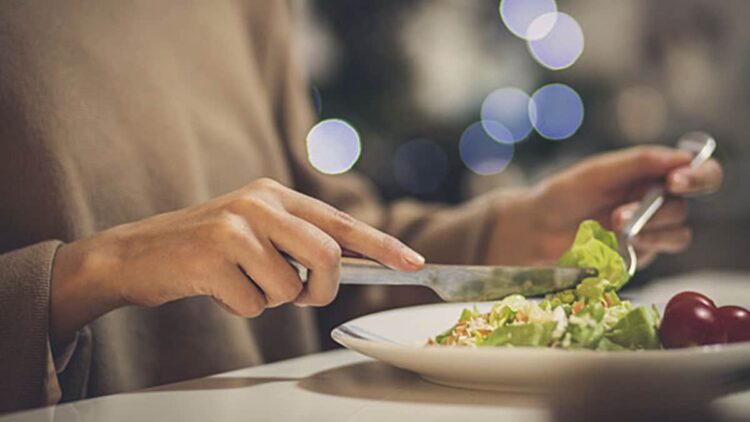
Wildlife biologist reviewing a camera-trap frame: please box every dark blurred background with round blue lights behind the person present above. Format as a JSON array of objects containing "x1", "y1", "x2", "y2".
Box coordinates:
[{"x1": 295, "y1": 0, "x2": 750, "y2": 347}]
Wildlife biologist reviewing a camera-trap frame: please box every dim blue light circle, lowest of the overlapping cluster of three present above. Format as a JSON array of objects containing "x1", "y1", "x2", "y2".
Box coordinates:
[{"x1": 458, "y1": 122, "x2": 513, "y2": 176}]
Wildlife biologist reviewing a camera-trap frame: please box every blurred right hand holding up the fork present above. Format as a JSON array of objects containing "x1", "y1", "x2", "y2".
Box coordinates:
[{"x1": 487, "y1": 146, "x2": 722, "y2": 265}]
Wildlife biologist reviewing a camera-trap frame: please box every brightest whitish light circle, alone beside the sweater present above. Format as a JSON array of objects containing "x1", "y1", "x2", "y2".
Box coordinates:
[{"x1": 307, "y1": 119, "x2": 362, "y2": 174}]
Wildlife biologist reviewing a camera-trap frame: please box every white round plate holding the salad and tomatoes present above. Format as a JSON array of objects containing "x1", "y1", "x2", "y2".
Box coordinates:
[{"x1": 331, "y1": 303, "x2": 750, "y2": 392}]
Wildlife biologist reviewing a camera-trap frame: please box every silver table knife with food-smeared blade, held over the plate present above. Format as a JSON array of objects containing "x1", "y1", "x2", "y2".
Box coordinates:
[{"x1": 289, "y1": 257, "x2": 598, "y2": 302}]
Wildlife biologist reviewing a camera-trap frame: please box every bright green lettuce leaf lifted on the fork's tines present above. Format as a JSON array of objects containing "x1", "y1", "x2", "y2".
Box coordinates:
[{"x1": 558, "y1": 220, "x2": 630, "y2": 290}]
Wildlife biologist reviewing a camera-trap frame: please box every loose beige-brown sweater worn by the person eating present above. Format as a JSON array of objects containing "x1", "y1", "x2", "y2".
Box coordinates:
[{"x1": 0, "y1": 0, "x2": 500, "y2": 411}]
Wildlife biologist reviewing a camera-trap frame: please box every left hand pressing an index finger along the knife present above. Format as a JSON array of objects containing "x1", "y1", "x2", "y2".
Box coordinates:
[{"x1": 51, "y1": 179, "x2": 424, "y2": 341}]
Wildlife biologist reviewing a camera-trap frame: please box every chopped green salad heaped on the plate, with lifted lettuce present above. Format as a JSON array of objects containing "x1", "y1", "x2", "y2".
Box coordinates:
[{"x1": 427, "y1": 220, "x2": 661, "y2": 350}]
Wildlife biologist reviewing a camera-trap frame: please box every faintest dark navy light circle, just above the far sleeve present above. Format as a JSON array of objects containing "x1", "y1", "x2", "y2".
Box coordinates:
[{"x1": 393, "y1": 139, "x2": 448, "y2": 194}]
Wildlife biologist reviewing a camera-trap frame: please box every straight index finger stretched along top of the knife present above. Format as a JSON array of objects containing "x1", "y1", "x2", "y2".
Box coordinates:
[{"x1": 284, "y1": 190, "x2": 424, "y2": 271}]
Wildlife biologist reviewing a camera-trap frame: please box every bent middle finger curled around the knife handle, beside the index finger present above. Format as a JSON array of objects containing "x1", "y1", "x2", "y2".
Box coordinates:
[{"x1": 271, "y1": 214, "x2": 341, "y2": 306}]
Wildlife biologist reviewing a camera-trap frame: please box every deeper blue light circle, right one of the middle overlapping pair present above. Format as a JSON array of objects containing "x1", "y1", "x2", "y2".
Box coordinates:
[{"x1": 529, "y1": 84, "x2": 583, "y2": 140}]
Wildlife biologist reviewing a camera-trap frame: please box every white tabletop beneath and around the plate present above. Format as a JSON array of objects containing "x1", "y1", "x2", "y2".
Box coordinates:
[{"x1": 0, "y1": 274, "x2": 750, "y2": 422}]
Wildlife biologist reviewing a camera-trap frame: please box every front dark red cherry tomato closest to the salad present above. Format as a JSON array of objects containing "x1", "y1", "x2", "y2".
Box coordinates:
[{"x1": 659, "y1": 300, "x2": 727, "y2": 349}]
